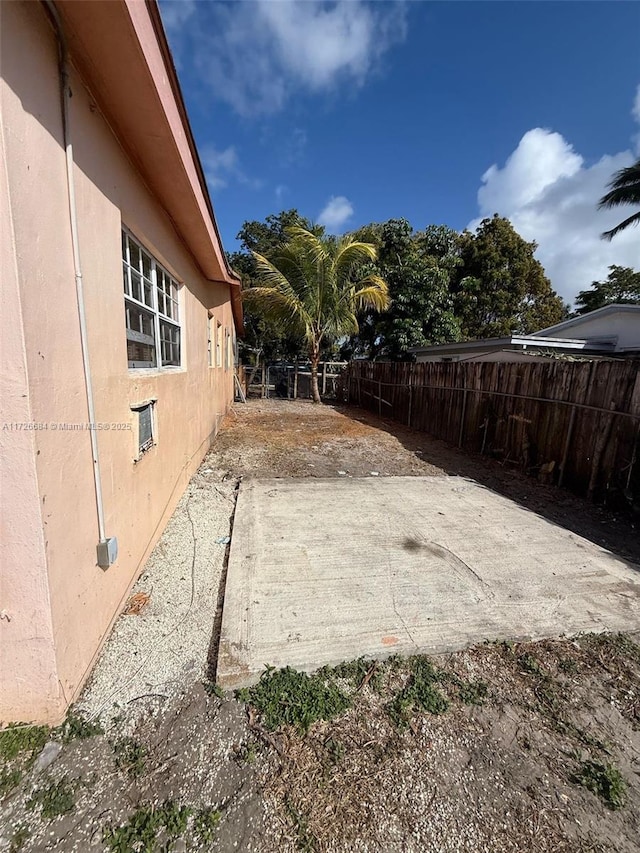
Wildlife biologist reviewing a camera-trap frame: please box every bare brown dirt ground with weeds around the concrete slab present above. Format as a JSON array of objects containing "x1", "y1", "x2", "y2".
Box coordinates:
[{"x1": 0, "y1": 401, "x2": 640, "y2": 853}]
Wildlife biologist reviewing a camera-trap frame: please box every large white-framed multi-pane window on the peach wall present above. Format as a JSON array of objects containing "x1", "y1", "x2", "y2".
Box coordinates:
[{"x1": 122, "y1": 229, "x2": 180, "y2": 368}]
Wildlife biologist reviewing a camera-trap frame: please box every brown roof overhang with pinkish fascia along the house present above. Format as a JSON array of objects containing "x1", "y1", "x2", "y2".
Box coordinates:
[{"x1": 49, "y1": 0, "x2": 242, "y2": 333}]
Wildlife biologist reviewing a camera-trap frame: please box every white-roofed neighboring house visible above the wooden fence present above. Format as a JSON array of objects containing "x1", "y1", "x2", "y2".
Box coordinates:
[{"x1": 409, "y1": 305, "x2": 640, "y2": 362}]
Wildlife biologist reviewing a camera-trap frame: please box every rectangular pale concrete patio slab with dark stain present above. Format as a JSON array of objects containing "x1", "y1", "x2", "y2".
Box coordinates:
[{"x1": 218, "y1": 477, "x2": 640, "y2": 687}]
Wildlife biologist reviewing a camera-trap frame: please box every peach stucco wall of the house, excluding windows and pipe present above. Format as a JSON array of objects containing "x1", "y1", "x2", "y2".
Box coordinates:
[{"x1": 0, "y1": 3, "x2": 233, "y2": 721}]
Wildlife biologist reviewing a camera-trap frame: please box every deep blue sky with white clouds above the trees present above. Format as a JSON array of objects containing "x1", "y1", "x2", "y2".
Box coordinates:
[{"x1": 161, "y1": 0, "x2": 640, "y2": 300}]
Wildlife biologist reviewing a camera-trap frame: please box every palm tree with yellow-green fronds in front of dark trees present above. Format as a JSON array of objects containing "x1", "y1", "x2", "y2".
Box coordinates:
[{"x1": 243, "y1": 226, "x2": 390, "y2": 403}]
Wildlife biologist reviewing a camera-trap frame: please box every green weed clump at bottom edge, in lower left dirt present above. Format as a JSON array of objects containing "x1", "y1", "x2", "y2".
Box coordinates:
[{"x1": 102, "y1": 800, "x2": 191, "y2": 853}]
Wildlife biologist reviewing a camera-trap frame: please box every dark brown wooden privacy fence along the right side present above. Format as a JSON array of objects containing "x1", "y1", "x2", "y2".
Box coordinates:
[{"x1": 339, "y1": 361, "x2": 640, "y2": 507}]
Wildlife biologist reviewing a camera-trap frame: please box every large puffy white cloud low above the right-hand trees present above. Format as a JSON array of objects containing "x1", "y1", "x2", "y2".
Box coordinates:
[{"x1": 468, "y1": 93, "x2": 640, "y2": 302}]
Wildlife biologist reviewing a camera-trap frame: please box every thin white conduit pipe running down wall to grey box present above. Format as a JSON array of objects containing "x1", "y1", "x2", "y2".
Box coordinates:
[{"x1": 43, "y1": 5, "x2": 117, "y2": 569}]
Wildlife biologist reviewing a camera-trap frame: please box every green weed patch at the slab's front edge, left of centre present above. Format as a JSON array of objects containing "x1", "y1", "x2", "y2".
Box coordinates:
[{"x1": 236, "y1": 666, "x2": 351, "y2": 734}]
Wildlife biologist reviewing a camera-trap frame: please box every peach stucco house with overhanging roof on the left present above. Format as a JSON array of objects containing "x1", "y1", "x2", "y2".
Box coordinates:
[{"x1": 0, "y1": 0, "x2": 242, "y2": 723}]
